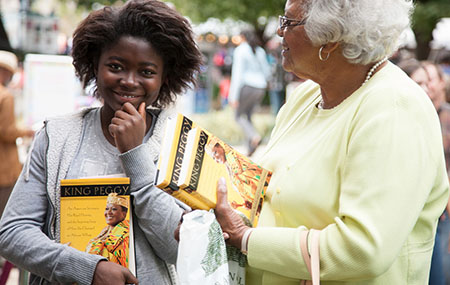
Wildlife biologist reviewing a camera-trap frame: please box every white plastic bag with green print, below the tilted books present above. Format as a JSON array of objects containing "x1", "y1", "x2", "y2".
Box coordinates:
[{"x1": 177, "y1": 211, "x2": 247, "y2": 285}]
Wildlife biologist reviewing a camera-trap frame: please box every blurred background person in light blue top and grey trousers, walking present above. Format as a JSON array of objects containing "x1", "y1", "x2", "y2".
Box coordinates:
[{"x1": 228, "y1": 30, "x2": 271, "y2": 156}]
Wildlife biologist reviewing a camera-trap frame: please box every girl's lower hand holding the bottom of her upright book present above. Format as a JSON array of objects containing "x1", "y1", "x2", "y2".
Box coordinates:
[{"x1": 92, "y1": 260, "x2": 139, "y2": 285}]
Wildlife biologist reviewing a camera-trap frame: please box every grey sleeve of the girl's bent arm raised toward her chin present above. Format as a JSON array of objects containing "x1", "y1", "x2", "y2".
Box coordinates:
[{"x1": 120, "y1": 143, "x2": 183, "y2": 264}]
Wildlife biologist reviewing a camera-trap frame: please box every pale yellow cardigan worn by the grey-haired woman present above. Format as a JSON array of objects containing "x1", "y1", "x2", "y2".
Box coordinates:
[{"x1": 247, "y1": 63, "x2": 448, "y2": 285}]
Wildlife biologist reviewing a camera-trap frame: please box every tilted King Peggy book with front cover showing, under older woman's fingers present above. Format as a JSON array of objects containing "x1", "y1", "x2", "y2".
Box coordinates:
[{"x1": 178, "y1": 127, "x2": 272, "y2": 226}]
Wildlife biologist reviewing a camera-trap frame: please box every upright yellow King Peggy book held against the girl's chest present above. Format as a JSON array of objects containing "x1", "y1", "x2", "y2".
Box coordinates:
[{"x1": 60, "y1": 177, "x2": 136, "y2": 276}]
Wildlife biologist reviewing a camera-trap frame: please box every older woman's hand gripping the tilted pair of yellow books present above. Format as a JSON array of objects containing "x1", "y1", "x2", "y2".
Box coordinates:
[{"x1": 215, "y1": 178, "x2": 249, "y2": 249}]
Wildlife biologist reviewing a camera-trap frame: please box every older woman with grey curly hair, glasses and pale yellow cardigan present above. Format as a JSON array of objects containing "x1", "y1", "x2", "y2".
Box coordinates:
[{"x1": 216, "y1": 0, "x2": 448, "y2": 285}]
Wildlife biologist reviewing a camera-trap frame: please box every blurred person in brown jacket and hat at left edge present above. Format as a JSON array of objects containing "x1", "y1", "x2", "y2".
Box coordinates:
[{"x1": 0, "y1": 50, "x2": 34, "y2": 217}]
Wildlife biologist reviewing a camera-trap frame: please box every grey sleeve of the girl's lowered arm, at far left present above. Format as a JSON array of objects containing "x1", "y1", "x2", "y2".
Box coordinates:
[{"x1": 0, "y1": 128, "x2": 104, "y2": 285}]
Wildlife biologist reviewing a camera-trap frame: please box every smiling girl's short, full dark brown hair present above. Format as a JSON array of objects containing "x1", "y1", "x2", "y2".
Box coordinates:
[{"x1": 72, "y1": 0, "x2": 202, "y2": 107}]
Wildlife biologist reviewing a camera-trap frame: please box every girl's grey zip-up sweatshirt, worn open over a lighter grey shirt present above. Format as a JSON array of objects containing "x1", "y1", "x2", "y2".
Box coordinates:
[{"x1": 0, "y1": 109, "x2": 183, "y2": 285}]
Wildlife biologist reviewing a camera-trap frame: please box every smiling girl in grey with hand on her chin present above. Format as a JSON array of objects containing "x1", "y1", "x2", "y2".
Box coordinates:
[{"x1": 0, "y1": 0, "x2": 201, "y2": 284}]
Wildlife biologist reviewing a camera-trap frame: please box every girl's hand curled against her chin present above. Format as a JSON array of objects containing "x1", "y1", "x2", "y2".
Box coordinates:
[{"x1": 108, "y1": 102, "x2": 147, "y2": 153}]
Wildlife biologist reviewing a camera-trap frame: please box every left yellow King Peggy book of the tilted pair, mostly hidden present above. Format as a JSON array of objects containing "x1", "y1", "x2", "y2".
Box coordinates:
[{"x1": 155, "y1": 113, "x2": 210, "y2": 209}]
